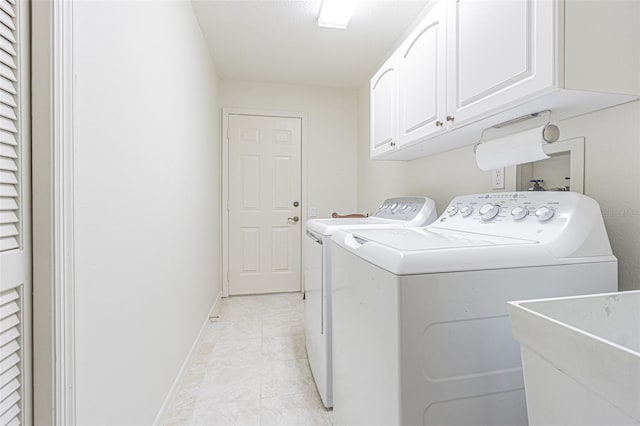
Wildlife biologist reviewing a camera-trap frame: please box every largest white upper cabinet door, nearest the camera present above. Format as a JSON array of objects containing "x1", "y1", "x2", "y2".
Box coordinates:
[{"x1": 447, "y1": 0, "x2": 557, "y2": 125}]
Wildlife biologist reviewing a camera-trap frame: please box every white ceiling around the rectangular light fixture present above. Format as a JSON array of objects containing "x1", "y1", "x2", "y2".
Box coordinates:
[{"x1": 192, "y1": 0, "x2": 427, "y2": 89}]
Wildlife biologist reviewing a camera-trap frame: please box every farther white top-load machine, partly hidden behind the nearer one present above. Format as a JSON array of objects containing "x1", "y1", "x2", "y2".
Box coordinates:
[{"x1": 304, "y1": 197, "x2": 437, "y2": 407}]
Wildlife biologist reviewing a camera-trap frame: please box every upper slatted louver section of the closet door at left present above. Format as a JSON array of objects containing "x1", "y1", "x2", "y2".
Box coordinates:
[{"x1": 0, "y1": 0, "x2": 21, "y2": 252}]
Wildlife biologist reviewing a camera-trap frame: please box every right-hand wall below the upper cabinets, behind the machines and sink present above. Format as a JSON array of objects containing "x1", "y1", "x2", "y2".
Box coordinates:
[{"x1": 358, "y1": 89, "x2": 640, "y2": 290}]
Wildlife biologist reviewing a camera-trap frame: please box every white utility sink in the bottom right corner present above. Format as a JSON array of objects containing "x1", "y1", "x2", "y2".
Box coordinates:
[{"x1": 509, "y1": 291, "x2": 640, "y2": 426}]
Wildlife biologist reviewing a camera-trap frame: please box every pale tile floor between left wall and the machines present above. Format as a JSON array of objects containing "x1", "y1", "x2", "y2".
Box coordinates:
[{"x1": 166, "y1": 293, "x2": 331, "y2": 426}]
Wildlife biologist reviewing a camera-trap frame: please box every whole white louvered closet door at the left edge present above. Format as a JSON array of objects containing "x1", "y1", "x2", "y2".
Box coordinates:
[{"x1": 0, "y1": 0, "x2": 32, "y2": 426}]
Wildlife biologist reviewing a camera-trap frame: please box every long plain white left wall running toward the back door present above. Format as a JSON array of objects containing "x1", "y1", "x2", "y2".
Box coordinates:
[{"x1": 73, "y1": 1, "x2": 220, "y2": 425}]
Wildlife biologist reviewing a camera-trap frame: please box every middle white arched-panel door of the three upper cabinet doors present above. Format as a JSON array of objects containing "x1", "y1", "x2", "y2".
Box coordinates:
[{"x1": 398, "y1": 2, "x2": 446, "y2": 147}]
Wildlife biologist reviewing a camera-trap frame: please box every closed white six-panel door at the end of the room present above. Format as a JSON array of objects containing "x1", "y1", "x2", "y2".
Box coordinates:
[{"x1": 227, "y1": 114, "x2": 302, "y2": 295}]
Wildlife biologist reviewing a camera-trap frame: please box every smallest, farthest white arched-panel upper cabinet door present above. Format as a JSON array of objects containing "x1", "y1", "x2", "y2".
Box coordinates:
[{"x1": 370, "y1": 54, "x2": 398, "y2": 157}]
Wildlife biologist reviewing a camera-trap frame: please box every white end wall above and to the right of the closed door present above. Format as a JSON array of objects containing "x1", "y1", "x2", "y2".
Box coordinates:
[{"x1": 219, "y1": 80, "x2": 358, "y2": 219}]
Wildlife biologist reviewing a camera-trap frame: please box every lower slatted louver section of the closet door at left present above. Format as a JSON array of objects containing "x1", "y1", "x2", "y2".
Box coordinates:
[{"x1": 0, "y1": 289, "x2": 22, "y2": 426}]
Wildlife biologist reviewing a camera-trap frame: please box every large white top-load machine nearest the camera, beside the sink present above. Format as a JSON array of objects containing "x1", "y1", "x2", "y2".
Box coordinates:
[{"x1": 332, "y1": 192, "x2": 617, "y2": 426}]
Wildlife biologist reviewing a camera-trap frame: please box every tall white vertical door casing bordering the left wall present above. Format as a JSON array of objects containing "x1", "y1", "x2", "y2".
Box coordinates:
[{"x1": 52, "y1": 1, "x2": 76, "y2": 426}]
